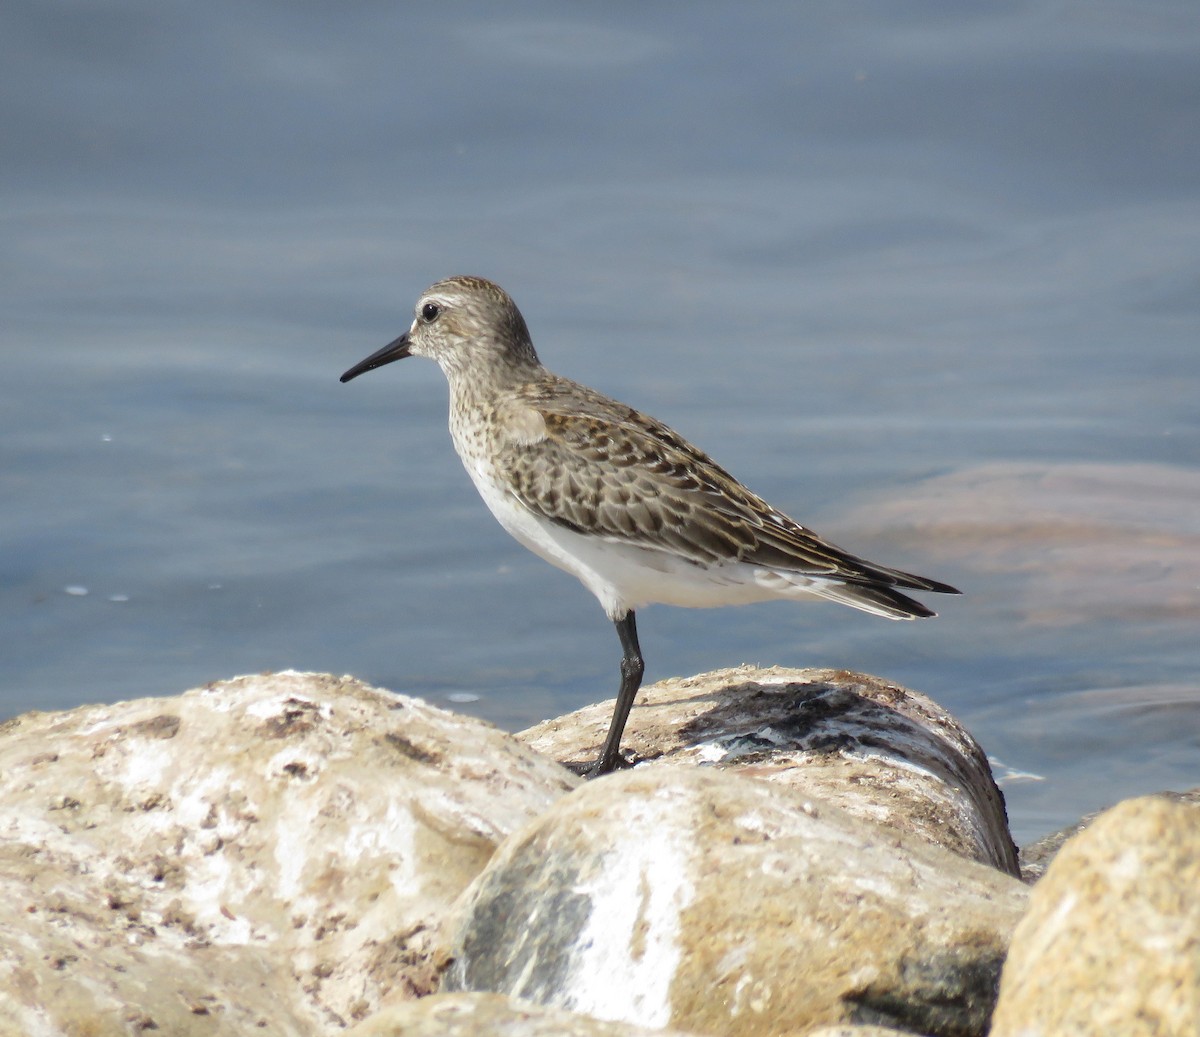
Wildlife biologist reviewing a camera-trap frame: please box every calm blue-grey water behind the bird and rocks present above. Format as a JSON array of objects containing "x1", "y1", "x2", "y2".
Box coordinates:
[{"x1": 0, "y1": 0, "x2": 1200, "y2": 840}]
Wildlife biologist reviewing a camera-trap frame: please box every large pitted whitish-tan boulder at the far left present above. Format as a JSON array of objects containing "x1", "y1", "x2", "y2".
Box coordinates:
[{"x1": 0, "y1": 673, "x2": 578, "y2": 1037}]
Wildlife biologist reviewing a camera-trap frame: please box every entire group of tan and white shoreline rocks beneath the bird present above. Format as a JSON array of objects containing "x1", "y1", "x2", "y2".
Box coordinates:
[{"x1": 0, "y1": 667, "x2": 1200, "y2": 1037}]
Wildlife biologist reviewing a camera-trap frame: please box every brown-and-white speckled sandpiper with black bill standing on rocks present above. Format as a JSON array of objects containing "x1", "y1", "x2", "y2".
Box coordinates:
[{"x1": 341, "y1": 276, "x2": 960, "y2": 777}]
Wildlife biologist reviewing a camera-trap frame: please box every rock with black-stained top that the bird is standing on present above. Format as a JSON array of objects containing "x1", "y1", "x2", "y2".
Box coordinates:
[{"x1": 517, "y1": 666, "x2": 1020, "y2": 875}]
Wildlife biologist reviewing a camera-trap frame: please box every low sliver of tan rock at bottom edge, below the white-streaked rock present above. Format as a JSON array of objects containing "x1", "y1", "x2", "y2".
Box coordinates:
[{"x1": 346, "y1": 994, "x2": 700, "y2": 1037}]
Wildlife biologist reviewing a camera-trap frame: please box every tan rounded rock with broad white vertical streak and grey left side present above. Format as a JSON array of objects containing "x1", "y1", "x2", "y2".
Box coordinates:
[{"x1": 442, "y1": 767, "x2": 1027, "y2": 1037}]
